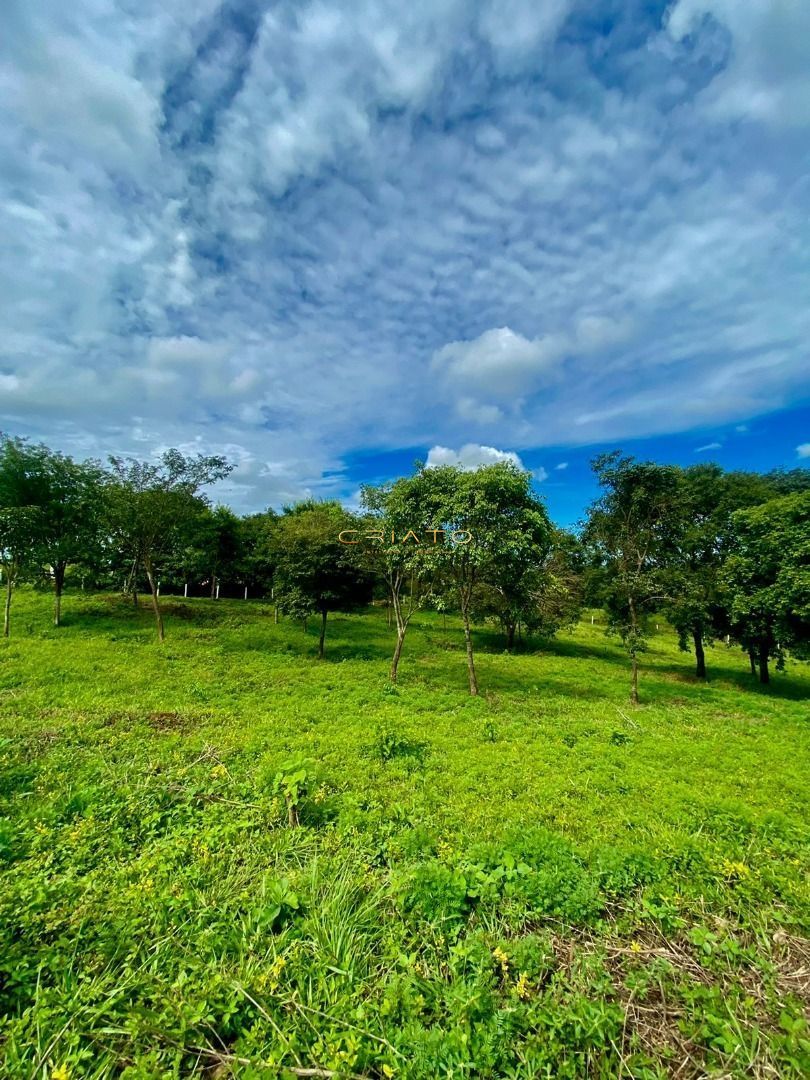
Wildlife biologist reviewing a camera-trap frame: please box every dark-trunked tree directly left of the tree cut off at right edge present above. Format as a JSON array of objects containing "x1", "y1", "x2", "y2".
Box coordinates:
[{"x1": 662, "y1": 464, "x2": 771, "y2": 678}]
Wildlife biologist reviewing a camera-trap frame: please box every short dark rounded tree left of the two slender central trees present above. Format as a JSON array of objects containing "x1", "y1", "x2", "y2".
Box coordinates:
[{"x1": 272, "y1": 502, "x2": 373, "y2": 660}]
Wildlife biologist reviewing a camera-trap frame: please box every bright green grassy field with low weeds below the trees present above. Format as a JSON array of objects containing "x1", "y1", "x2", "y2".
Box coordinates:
[{"x1": 0, "y1": 590, "x2": 810, "y2": 1080}]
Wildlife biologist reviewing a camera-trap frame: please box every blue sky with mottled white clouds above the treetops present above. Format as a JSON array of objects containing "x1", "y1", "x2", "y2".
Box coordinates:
[{"x1": 0, "y1": 0, "x2": 810, "y2": 518}]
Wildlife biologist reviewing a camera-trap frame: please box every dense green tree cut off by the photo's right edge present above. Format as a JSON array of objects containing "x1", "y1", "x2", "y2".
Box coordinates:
[{"x1": 721, "y1": 490, "x2": 810, "y2": 684}]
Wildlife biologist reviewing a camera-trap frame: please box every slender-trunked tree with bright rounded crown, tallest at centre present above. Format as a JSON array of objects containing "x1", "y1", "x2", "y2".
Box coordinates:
[{"x1": 419, "y1": 462, "x2": 551, "y2": 694}]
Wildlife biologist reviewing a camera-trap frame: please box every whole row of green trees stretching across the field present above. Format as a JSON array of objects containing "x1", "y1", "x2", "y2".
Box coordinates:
[{"x1": 0, "y1": 436, "x2": 810, "y2": 702}]
